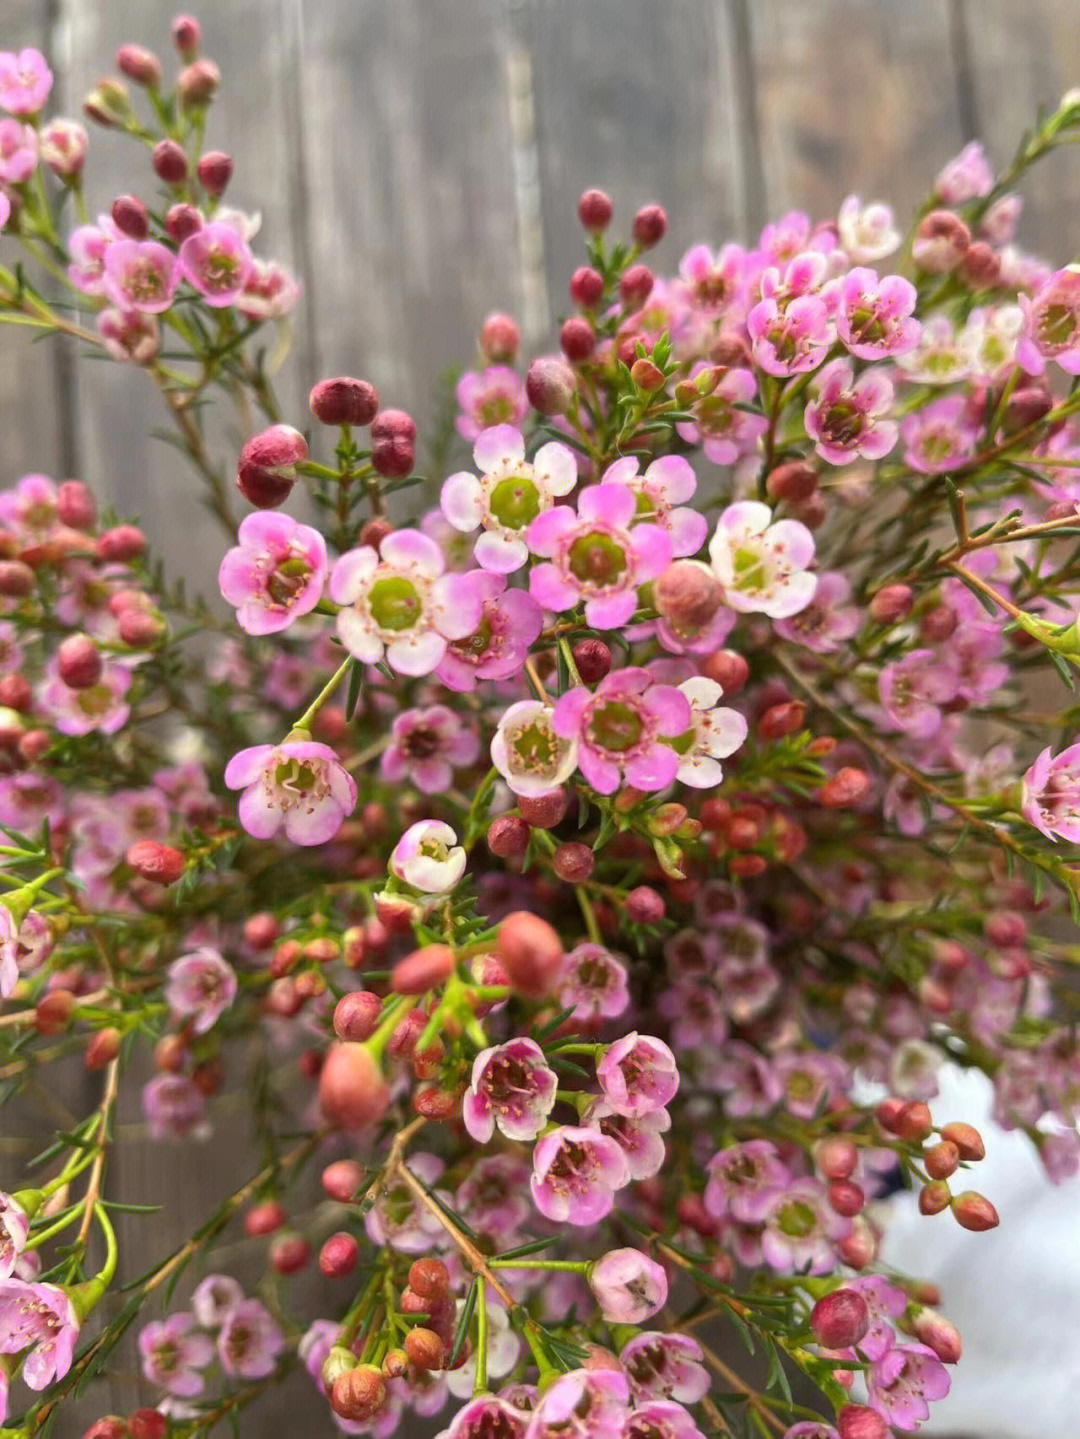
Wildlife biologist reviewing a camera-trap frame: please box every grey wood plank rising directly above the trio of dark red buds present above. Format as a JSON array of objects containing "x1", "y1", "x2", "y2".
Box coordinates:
[{"x1": 301, "y1": 0, "x2": 522, "y2": 432}]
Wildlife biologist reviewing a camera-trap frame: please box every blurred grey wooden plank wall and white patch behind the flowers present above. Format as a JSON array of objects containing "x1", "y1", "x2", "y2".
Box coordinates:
[{"x1": 0, "y1": 0, "x2": 1080, "y2": 1439}]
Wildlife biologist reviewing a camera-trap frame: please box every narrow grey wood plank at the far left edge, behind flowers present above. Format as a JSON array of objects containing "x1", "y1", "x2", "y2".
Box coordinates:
[{"x1": 0, "y1": 0, "x2": 65, "y2": 488}]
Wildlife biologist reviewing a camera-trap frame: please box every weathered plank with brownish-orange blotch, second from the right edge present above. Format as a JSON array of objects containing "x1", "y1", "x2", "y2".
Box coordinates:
[{"x1": 749, "y1": 0, "x2": 962, "y2": 220}]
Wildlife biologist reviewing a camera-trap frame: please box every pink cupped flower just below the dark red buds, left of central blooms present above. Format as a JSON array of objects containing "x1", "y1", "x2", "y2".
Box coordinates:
[{"x1": 217, "y1": 509, "x2": 326, "y2": 635}]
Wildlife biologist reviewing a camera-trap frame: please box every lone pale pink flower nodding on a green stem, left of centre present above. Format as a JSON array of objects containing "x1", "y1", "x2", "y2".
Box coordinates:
[{"x1": 224, "y1": 740, "x2": 357, "y2": 845}]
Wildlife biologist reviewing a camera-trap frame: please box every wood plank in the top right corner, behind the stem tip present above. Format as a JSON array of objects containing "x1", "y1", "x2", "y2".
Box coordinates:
[{"x1": 956, "y1": 0, "x2": 1080, "y2": 265}]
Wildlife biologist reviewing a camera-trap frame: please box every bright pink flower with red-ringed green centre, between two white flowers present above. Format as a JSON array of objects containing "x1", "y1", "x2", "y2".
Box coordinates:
[{"x1": 552, "y1": 668, "x2": 690, "y2": 794}]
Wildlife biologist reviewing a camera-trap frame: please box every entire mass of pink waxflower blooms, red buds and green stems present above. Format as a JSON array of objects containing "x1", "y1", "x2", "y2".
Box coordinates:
[{"x1": 0, "y1": 16, "x2": 1080, "y2": 1439}]
